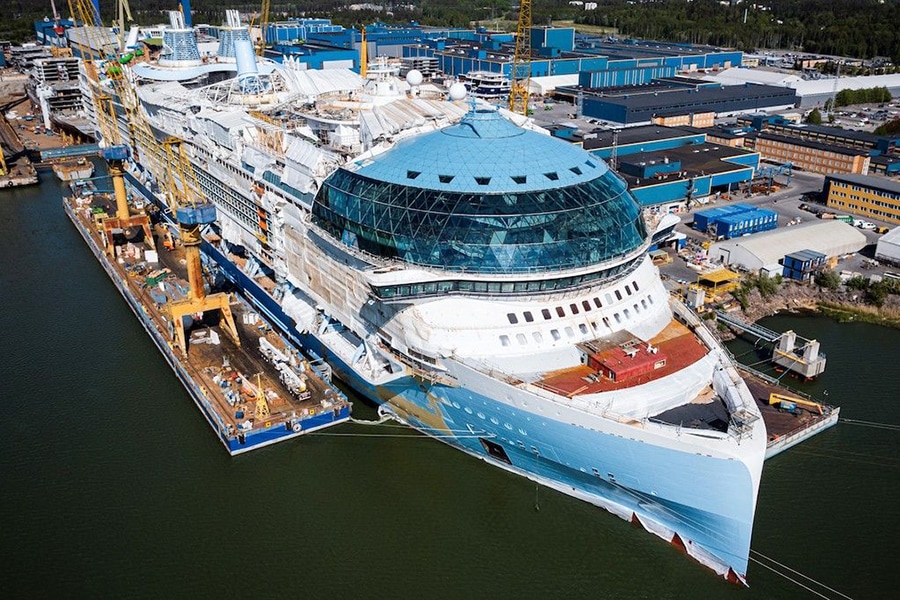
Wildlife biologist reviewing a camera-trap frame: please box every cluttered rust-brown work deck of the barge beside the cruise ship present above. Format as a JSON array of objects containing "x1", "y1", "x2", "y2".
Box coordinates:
[{"x1": 66, "y1": 194, "x2": 349, "y2": 453}]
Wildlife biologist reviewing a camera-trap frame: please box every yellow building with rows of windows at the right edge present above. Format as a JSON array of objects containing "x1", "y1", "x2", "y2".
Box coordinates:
[{"x1": 822, "y1": 175, "x2": 900, "y2": 223}]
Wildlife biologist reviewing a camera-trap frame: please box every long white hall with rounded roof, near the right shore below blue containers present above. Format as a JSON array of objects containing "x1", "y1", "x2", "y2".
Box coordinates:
[{"x1": 709, "y1": 221, "x2": 867, "y2": 275}]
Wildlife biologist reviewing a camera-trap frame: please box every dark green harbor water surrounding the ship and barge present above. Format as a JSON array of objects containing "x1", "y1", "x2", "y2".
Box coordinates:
[{"x1": 0, "y1": 171, "x2": 900, "y2": 599}]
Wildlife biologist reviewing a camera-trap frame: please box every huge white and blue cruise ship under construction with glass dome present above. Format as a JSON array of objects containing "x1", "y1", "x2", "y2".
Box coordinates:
[{"x1": 84, "y1": 14, "x2": 766, "y2": 582}]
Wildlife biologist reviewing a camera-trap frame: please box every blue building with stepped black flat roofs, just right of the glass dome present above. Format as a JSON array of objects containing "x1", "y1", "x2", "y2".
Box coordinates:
[{"x1": 582, "y1": 125, "x2": 760, "y2": 211}]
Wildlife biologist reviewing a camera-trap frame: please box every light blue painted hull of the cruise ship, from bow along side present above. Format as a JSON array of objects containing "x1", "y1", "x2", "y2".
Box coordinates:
[{"x1": 204, "y1": 223, "x2": 764, "y2": 582}]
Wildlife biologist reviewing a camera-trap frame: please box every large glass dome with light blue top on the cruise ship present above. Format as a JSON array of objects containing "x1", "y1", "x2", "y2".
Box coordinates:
[{"x1": 313, "y1": 111, "x2": 647, "y2": 274}]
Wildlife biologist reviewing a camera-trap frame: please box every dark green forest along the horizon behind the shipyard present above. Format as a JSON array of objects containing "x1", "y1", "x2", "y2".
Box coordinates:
[{"x1": 0, "y1": 0, "x2": 900, "y2": 64}]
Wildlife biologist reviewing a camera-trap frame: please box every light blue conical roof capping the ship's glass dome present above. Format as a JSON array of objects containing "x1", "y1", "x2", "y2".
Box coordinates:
[{"x1": 347, "y1": 108, "x2": 608, "y2": 194}]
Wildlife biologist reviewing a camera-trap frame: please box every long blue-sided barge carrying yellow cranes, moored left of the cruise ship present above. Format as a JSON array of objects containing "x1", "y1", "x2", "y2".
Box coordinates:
[{"x1": 64, "y1": 188, "x2": 350, "y2": 455}]
